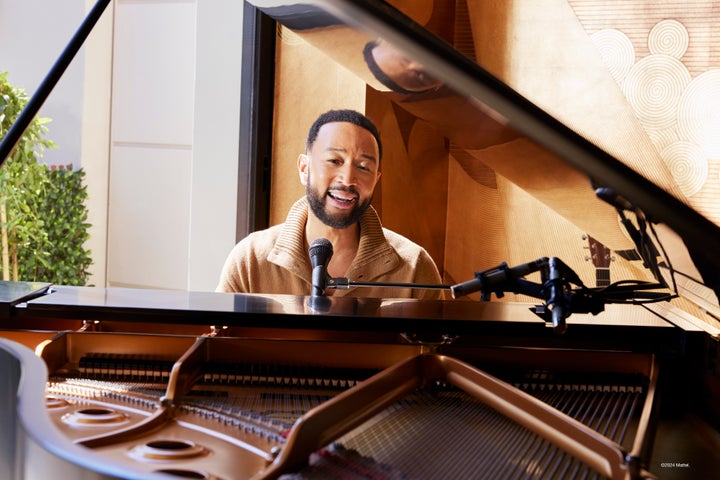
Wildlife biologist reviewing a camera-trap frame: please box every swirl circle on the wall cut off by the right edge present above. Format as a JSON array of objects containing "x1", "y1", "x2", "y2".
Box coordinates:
[{"x1": 677, "y1": 69, "x2": 720, "y2": 160}]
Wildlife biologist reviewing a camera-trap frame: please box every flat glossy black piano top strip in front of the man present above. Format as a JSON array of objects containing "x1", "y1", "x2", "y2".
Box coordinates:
[{"x1": 24, "y1": 286, "x2": 545, "y2": 329}]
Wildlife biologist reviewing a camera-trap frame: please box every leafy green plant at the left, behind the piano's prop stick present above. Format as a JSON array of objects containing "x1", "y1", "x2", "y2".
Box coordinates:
[{"x1": 0, "y1": 72, "x2": 92, "y2": 285}]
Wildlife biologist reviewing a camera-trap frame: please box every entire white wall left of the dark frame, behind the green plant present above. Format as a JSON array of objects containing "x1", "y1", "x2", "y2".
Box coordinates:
[{"x1": 0, "y1": 0, "x2": 243, "y2": 290}]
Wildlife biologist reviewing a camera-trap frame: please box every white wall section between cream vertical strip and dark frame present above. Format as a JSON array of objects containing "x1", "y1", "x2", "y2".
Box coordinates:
[{"x1": 108, "y1": 0, "x2": 243, "y2": 290}]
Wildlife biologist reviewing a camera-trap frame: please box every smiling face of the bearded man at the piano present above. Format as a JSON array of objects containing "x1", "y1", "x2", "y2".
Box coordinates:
[{"x1": 298, "y1": 122, "x2": 380, "y2": 228}]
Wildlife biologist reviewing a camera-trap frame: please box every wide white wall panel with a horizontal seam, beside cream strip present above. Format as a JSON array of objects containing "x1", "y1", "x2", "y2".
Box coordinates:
[{"x1": 107, "y1": 0, "x2": 196, "y2": 289}]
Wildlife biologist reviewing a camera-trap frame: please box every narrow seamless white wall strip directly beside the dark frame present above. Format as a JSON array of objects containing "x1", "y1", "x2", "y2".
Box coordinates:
[{"x1": 187, "y1": 0, "x2": 244, "y2": 290}]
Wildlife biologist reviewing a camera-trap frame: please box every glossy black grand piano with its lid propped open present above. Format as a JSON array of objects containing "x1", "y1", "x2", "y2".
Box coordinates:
[{"x1": 0, "y1": 0, "x2": 720, "y2": 480}]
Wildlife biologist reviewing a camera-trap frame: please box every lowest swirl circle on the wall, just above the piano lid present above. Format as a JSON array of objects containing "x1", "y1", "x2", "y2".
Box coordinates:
[{"x1": 660, "y1": 141, "x2": 708, "y2": 197}]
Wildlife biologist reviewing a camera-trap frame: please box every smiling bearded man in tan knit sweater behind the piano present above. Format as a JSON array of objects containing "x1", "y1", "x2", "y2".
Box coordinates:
[{"x1": 217, "y1": 110, "x2": 443, "y2": 298}]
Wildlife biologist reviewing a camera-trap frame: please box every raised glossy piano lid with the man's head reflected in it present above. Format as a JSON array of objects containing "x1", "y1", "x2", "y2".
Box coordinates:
[{"x1": 249, "y1": 0, "x2": 720, "y2": 303}]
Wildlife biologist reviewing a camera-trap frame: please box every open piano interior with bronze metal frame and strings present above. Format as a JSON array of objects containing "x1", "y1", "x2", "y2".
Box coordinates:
[{"x1": 8, "y1": 324, "x2": 659, "y2": 478}]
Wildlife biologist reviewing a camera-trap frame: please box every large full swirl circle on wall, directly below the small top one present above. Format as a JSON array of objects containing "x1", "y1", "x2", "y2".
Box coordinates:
[{"x1": 623, "y1": 55, "x2": 691, "y2": 129}]
